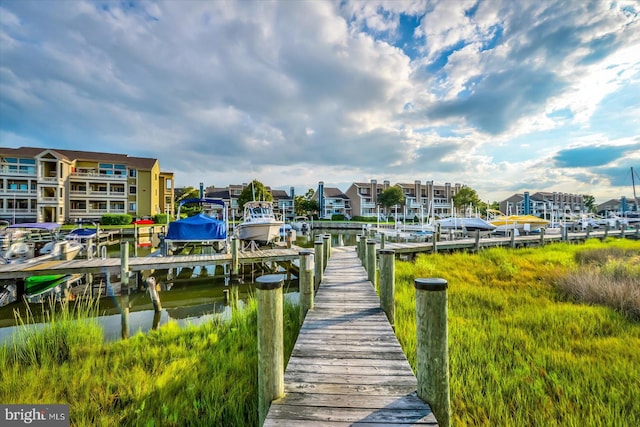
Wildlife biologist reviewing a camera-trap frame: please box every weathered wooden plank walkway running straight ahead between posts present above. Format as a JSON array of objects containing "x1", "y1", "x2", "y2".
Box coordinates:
[{"x1": 264, "y1": 247, "x2": 438, "y2": 427}]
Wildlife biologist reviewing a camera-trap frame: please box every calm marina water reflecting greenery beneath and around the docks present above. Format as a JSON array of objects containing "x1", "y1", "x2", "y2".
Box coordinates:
[{"x1": 0, "y1": 230, "x2": 360, "y2": 343}]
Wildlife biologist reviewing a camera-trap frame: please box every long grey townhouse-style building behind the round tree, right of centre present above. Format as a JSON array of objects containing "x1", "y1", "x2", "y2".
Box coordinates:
[{"x1": 345, "y1": 179, "x2": 462, "y2": 220}]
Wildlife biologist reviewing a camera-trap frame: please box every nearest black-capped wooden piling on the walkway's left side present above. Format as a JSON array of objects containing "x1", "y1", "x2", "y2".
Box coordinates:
[{"x1": 256, "y1": 274, "x2": 284, "y2": 425}]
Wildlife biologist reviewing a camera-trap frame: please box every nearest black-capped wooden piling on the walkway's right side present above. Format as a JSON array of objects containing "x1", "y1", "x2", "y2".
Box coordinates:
[{"x1": 414, "y1": 278, "x2": 451, "y2": 427}]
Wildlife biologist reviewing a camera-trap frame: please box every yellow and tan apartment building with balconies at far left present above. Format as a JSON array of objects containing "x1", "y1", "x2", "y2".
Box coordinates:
[{"x1": 0, "y1": 147, "x2": 174, "y2": 223}]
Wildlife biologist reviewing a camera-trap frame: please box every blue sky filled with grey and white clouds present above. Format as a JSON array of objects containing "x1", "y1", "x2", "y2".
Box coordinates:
[{"x1": 0, "y1": 0, "x2": 640, "y2": 202}]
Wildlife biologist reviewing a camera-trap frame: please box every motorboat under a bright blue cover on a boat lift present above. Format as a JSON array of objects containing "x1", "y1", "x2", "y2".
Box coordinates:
[{"x1": 164, "y1": 197, "x2": 227, "y2": 255}]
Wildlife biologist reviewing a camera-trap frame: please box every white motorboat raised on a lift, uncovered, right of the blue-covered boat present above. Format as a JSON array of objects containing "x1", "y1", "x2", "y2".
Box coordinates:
[{"x1": 236, "y1": 200, "x2": 284, "y2": 244}]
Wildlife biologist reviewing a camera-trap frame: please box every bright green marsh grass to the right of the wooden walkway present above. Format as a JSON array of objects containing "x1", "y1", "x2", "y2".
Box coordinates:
[{"x1": 396, "y1": 240, "x2": 640, "y2": 426}]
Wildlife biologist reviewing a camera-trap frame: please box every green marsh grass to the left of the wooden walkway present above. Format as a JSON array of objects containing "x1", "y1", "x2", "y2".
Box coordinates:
[{"x1": 0, "y1": 299, "x2": 299, "y2": 426}]
